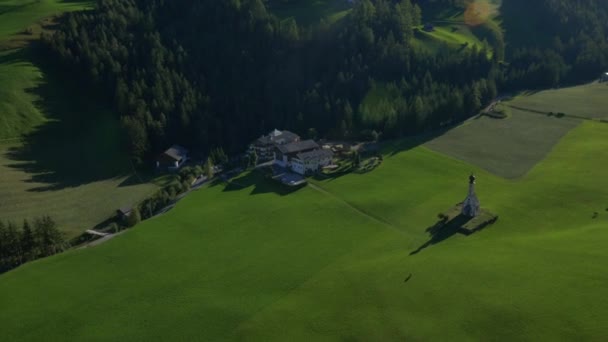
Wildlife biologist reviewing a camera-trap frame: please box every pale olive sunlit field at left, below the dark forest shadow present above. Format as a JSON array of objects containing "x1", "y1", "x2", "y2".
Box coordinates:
[{"x1": 0, "y1": 144, "x2": 158, "y2": 238}]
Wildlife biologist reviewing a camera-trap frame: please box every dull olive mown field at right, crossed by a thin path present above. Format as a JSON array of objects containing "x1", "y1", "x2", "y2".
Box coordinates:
[{"x1": 426, "y1": 83, "x2": 608, "y2": 178}]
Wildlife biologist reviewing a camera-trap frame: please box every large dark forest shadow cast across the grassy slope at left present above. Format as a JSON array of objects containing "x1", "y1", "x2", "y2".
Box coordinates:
[{"x1": 0, "y1": 47, "x2": 134, "y2": 191}]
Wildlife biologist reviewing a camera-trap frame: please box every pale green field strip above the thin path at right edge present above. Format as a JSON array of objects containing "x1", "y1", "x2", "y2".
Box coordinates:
[{"x1": 508, "y1": 83, "x2": 608, "y2": 119}]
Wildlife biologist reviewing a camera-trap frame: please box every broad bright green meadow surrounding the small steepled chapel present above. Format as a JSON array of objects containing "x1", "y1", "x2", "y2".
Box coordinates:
[{"x1": 0, "y1": 122, "x2": 608, "y2": 341}]
